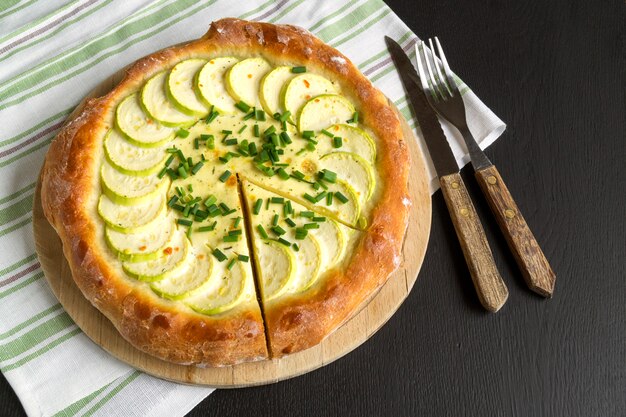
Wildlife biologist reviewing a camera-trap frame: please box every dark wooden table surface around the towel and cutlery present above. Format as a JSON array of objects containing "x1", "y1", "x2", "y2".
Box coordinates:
[{"x1": 0, "y1": 0, "x2": 626, "y2": 417}]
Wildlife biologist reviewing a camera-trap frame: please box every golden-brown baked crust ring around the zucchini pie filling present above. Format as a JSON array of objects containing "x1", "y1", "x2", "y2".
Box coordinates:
[{"x1": 41, "y1": 19, "x2": 409, "y2": 366}]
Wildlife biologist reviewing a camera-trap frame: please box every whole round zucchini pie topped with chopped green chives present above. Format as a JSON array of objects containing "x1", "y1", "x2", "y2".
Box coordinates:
[{"x1": 41, "y1": 19, "x2": 410, "y2": 366}]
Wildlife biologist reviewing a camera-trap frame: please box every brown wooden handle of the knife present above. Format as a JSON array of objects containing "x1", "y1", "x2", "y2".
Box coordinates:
[{"x1": 439, "y1": 173, "x2": 509, "y2": 313}]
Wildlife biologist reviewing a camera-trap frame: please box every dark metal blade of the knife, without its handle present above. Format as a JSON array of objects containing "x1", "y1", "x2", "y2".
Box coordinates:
[{"x1": 385, "y1": 36, "x2": 459, "y2": 178}]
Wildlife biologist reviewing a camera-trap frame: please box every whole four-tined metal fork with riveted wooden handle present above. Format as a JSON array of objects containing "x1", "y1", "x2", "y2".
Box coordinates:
[{"x1": 415, "y1": 37, "x2": 556, "y2": 297}]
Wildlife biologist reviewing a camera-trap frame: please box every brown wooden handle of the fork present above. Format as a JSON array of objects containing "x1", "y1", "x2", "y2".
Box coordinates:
[{"x1": 476, "y1": 165, "x2": 556, "y2": 297}]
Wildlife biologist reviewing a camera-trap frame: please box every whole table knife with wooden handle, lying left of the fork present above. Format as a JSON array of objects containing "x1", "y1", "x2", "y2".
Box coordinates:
[{"x1": 385, "y1": 36, "x2": 509, "y2": 313}]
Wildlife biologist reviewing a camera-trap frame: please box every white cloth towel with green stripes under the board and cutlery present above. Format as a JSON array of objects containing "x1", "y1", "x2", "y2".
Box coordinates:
[{"x1": 0, "y1": 0, "x2": 504, "y2": 417}]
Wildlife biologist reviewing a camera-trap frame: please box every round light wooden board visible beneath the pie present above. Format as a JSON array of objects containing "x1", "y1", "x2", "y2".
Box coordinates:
[{"x1": 33, "y1": 65, "x2": 431, "y2": 388}]
